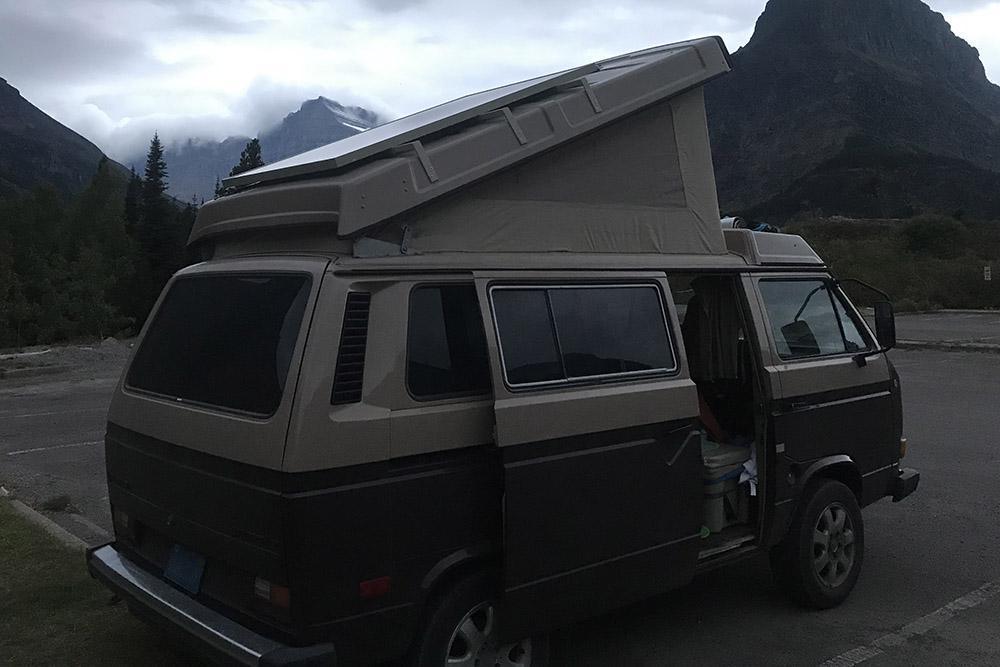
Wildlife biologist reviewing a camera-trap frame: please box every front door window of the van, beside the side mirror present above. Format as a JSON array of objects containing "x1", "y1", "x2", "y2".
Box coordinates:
[{"x1": 760, "y1": 280, "x2": 866, "y2": 359}]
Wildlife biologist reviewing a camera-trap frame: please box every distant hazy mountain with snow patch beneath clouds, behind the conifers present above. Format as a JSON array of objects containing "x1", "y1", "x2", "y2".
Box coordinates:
[{"x1": 160, "y1": 97, "x2": 380, "y2": 201}]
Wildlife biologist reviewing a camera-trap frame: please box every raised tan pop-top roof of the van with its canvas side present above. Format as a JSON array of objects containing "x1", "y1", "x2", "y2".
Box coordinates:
[{"x1": 190, "y1": 38, "x2": 729, "y2": 254}]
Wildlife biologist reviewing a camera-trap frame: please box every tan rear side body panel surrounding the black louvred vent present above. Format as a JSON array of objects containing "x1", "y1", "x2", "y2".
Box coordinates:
[{"x1": 284, "y1": 271, "x2": 493, "y2": 472}]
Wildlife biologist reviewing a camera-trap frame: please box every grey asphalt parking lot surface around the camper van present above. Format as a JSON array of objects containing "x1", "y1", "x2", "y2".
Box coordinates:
[{"x1": 0, "y1": 314, "x2": 1000, "y2": 667}]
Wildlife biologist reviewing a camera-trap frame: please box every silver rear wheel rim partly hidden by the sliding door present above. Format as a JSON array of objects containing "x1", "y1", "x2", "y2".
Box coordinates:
[{"x1": 445, "y1": 602, "x2": 531, "y2": 667}]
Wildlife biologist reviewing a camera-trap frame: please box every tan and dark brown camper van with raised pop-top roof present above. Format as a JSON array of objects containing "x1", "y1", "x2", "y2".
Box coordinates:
[{"x1": 87, "y1": 38, "x2": 919, "y2": 667}]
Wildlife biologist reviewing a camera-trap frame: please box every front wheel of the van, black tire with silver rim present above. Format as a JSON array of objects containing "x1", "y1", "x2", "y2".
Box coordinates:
[{"x1": 771, "y1": 479, "x2": 865, "y2": 609}]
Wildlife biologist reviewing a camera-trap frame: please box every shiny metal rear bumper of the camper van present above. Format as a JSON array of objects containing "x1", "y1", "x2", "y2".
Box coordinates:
[{"x1": 87, "y1": 544, "x2": 337, "y2": 667}]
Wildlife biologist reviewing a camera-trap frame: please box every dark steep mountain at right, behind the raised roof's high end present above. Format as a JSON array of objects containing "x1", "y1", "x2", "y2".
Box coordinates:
[{"x1": 706, "y1": 0, "x2": 1000, "y2": 218}]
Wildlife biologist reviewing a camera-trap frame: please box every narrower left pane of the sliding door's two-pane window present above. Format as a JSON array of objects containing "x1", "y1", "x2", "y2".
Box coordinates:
[{"x1": 493, "y1": 290, "x2": 565, "y2": 384}]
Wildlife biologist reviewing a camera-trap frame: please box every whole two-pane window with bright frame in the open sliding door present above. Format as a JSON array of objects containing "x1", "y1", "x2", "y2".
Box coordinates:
[{"x1": 491, "y1": 285, "x2": 675, "y2": 385}]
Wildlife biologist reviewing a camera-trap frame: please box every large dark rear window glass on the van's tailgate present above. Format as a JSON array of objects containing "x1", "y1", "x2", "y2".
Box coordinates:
[{"x1": 127, "y1": 274, "x2": 310, "y2": 415}]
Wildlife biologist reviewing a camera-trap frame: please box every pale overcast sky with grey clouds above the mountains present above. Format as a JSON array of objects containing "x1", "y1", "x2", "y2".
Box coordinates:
[{"x1": 0, "y1": 0, "x2": 1000, "y2": 160}]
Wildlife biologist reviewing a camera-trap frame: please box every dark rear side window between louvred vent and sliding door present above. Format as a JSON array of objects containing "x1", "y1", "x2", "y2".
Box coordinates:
[{"x1": 406, "y1": 285, "x2": 490, "y2": 399}]
